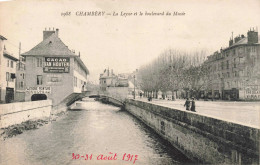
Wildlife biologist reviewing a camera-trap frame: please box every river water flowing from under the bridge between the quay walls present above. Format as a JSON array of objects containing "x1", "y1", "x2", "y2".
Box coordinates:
[{"x1": 0, "y1": 102, "x2": 191, "y2": 165}]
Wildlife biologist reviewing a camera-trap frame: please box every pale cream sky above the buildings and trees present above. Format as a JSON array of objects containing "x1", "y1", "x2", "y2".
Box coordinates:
[{"x1": 0, "y1": 0, "x2": 260, "y2": 83}]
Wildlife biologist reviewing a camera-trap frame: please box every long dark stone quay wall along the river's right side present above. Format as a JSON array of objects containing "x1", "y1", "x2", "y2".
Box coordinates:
[{"x1": 125, "y1": 99, "x2": 260, "y2": 164}]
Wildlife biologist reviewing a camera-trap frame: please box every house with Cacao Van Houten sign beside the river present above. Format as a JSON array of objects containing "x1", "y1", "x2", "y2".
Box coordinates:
[{"x1": 22, "y1": 29, "x2": 89, "y2": 105}]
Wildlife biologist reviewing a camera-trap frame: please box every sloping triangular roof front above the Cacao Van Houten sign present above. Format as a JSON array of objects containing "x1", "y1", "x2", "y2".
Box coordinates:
[{"x1": 22, "y1": 33, "x2": 75, "y2": 56}]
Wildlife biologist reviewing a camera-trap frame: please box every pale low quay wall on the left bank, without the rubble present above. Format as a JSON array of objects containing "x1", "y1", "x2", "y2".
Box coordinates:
[{"x1": 0, "y1": 100, "x2": 52, "y2": 128}]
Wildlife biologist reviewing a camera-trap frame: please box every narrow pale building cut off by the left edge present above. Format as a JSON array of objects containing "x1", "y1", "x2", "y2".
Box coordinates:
[{"x1": 0, "y1": 35, "x2": 18, "y2": 103}]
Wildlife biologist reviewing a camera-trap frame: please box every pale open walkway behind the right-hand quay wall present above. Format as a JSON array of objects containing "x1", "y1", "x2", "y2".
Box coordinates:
[{"x1": 136, "y1": 97, "x2": 260, "y2": 128}]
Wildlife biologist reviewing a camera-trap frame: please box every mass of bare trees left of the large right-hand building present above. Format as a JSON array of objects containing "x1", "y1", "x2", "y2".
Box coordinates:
[{"x1": 137, "y1": 49, "x2": 209, "y2": 92}]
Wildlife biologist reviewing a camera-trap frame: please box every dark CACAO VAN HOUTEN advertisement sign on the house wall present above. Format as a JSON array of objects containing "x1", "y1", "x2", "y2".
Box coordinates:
[{"x1": 43, "y1": 57, "x2": 70, "y2": 73}]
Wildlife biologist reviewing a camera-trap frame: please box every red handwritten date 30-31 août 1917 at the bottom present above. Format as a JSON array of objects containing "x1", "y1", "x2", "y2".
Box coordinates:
[{"x1": 72, "y1": 152, "x2": 138, "y2": 164}]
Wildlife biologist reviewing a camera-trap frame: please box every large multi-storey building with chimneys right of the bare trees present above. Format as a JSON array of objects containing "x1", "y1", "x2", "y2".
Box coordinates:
[{"x1": 205, "y1": 29, "x2": 260, "y2": 100}]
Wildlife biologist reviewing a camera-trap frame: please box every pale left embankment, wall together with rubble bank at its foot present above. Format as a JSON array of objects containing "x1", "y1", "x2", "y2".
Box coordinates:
[{"x1": 0, "y1": 100, "x2": 66, "y2": 139}]
